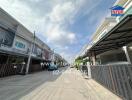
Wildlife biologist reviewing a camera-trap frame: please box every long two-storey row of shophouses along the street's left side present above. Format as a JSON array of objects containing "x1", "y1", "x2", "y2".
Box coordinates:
[{"x1": 0, "y1": 8, "x2": 66, "y2": 76}]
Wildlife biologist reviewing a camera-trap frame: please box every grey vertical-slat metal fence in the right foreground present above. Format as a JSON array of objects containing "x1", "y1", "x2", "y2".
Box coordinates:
[{"x1": 91, "y1": 64, "x2": 132, "y2": 100}]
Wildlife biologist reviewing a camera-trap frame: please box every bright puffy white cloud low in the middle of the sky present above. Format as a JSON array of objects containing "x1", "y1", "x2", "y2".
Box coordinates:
[{"x1": 46, "y1": 25, "x2": 76, "y2": 47}]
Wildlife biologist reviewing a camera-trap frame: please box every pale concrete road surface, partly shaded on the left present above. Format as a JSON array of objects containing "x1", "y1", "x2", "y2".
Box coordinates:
[{"x1": 0, "y1": 68, "x2": 121, "y2": 100}]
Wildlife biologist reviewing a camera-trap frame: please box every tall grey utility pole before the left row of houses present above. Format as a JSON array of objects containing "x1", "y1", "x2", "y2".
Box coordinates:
[{"x1": 26, "y1": 31, "x2": 35, "y2": 74}]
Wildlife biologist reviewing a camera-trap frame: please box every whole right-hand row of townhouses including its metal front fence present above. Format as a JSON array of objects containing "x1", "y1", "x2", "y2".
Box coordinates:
[{"x1": 75, "y1": 0, "x2": 132, "y2": 100}]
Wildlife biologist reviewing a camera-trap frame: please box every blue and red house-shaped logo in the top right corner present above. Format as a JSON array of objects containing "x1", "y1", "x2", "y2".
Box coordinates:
[{"x1": 110, "y1": 5, "x2": 124, "y2": 17}]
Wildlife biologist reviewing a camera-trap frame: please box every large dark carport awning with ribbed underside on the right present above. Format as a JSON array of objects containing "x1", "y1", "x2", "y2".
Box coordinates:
[{"x1": 87, "y1": 15, "x2": 132, "y2": 55}]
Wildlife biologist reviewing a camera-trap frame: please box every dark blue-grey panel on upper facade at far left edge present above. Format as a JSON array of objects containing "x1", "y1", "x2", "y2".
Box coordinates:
[{"x1": 0, "y1": 27, "x2": 15, "y2": 47}]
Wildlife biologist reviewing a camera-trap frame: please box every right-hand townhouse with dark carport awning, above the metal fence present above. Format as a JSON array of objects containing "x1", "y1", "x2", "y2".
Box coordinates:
[{"x1": 84, "y1": 0, "x2": 132, "y2": 65}]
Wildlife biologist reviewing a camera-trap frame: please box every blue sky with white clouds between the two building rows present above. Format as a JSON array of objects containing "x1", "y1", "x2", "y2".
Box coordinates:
[{"x1": 0, "y1": 0, "x2": 116, "y2": 62}]
